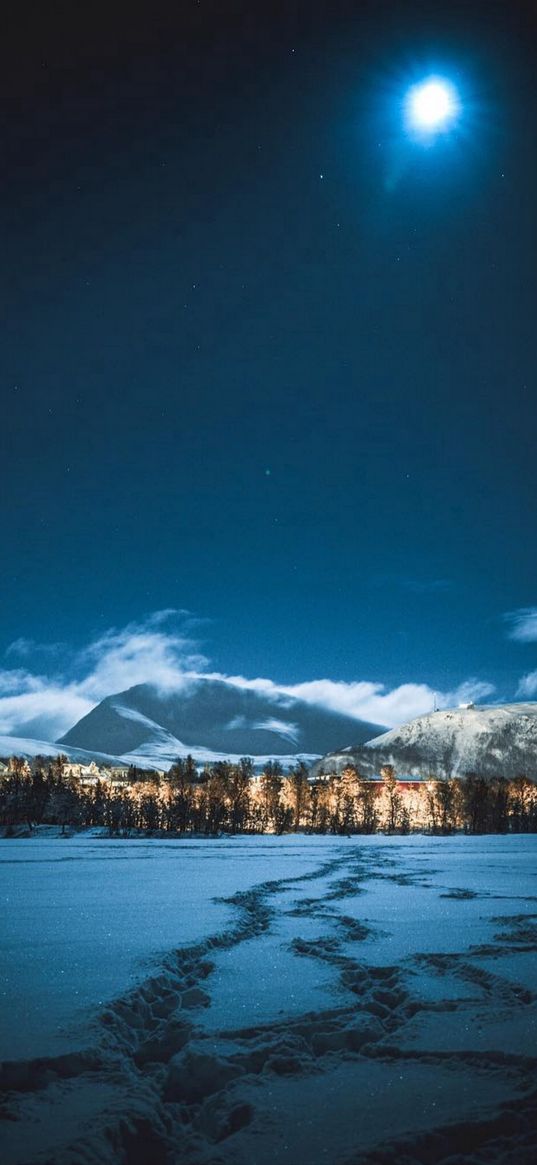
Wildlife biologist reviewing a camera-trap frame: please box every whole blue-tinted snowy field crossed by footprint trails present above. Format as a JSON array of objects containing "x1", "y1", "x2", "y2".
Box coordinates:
[{"x1": 0, "y1": 836, "x2": 537, "y2": 1165}]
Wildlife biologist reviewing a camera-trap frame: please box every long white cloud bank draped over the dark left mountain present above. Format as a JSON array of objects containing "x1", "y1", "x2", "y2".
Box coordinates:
[{"x1": 0, "y1": 610, "x2": 496, "y2": 740}]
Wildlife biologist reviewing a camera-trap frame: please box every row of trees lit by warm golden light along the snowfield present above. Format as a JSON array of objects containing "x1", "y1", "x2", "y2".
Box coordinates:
[{"x1": 0, "y1": 756, "x2": 537, "y2": 838}]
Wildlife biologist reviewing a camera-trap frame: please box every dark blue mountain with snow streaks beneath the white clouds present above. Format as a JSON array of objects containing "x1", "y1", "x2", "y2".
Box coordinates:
[{"x1": 57, "y1": 678, "x2": 379, "y2": 768}]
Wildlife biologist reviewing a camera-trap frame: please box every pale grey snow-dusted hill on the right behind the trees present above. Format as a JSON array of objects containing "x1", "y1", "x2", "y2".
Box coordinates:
[{"x1": 315, "y1": 704, "x2": 537, "y2": 779}]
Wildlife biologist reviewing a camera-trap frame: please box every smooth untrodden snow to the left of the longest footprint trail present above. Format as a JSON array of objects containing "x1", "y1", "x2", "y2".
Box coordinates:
[{"x1": 0, "y1": 835, "x2": 333, "y2": 1059}]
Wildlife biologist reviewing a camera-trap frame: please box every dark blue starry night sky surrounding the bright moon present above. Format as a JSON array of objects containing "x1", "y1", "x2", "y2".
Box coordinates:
[{"x1": 0, "y1": 0, "x2": 537, "y2": 699}]
